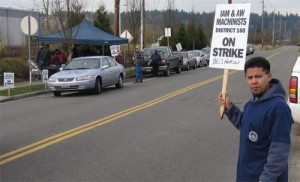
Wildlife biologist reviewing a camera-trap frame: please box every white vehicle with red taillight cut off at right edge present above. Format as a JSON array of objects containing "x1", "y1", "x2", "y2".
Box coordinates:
[{"x1": 287, "y1": 56, "x2": 300, "y2": 124}]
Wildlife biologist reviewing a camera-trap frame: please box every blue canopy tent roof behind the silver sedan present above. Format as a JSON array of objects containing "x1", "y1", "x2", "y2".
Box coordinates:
[{"x1": 36, "y1": 19, "x2": 128, "y2": 45}]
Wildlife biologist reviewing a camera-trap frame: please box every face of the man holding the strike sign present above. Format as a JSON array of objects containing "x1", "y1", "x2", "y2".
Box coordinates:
[{"x1": 246, "y1": 67, "x2": 272, "y2": 97}]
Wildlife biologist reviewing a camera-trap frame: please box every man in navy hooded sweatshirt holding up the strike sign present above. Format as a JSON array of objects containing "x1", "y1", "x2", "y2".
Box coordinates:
[{"x1": 218, "y1": 57, "x2": 293, "y2": 181}]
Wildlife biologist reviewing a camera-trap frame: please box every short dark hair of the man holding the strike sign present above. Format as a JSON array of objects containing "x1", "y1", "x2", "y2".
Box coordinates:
[{"x1": 244, "y1": 57, "x2": 271, "y2": 74}]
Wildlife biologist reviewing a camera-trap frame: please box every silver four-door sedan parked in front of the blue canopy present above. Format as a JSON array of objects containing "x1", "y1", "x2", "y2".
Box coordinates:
[{"x1": 47, "y1": 56, "x2": 126, "y2": 96}]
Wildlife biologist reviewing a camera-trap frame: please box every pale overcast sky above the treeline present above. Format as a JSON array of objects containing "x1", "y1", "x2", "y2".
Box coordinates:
[{"x1": 0, "y1": 0, "x2": 300, "y2": 15}]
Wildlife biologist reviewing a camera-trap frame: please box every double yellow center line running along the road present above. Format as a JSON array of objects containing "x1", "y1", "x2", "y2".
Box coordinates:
[{"x1": 0, "y1": 71, "x2": 236, "y2": 165}]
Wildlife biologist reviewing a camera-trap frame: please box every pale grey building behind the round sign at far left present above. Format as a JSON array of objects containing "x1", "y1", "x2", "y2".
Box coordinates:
[{"x1": 0, "y1": 7, "x2": 44, "y2": 47}]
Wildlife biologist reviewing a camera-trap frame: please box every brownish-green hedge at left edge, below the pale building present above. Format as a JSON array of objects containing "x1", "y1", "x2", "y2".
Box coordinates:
[{"x1": 0, "y1": 58, "x2": 29, "y2": 78}]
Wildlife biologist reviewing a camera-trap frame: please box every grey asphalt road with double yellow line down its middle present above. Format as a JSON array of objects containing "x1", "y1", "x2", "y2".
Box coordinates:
[{"x1": 0, "y1": 47, "x2": 300, "y2": 181}]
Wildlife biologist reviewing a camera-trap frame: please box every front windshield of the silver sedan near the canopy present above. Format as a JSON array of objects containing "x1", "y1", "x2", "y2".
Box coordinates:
[{"x1": 64, "y1": 58, "x2": 100, "y2": 70}]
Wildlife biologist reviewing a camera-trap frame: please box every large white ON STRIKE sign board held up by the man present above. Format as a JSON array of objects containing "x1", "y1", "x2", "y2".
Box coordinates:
[{"x1": 209, "y1": 3, "x2": 251, "y2": 70}]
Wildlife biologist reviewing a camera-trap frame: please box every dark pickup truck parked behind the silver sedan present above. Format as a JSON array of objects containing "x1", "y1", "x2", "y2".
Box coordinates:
[{"x1": 142, "y1": 46, "x2": 183, "y2": 76}]
